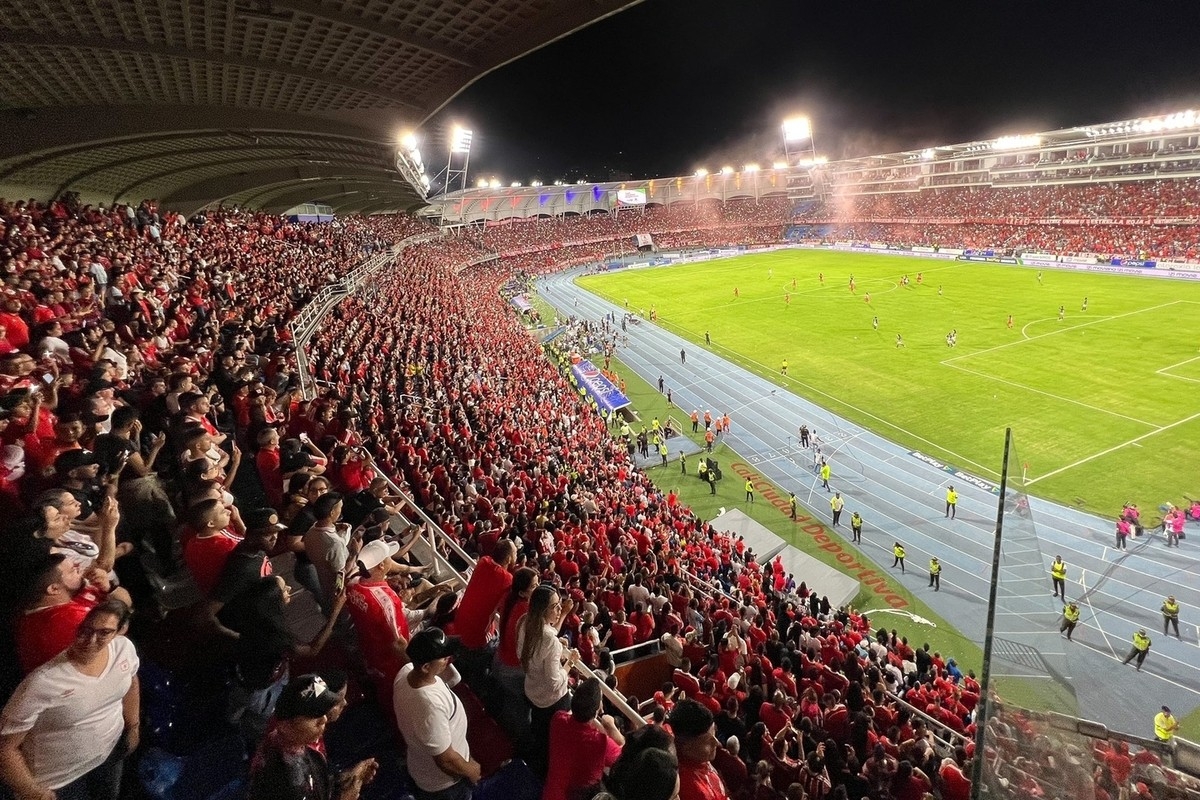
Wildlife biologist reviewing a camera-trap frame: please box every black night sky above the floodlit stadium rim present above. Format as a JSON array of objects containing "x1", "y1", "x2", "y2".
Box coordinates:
[{"x1": 436, "y1": 0, "x2": 1200, "y2": 184}]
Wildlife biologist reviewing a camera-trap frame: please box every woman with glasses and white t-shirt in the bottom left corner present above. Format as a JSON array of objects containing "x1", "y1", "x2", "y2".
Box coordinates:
[{"x1": 0, "y1": 600, "x2": 142, "y2": 800}]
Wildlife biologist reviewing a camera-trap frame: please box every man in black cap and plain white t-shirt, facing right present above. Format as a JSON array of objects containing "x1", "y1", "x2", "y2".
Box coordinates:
[{"x1": 394, "y1": 627, "x2": 481, "y2": 800}]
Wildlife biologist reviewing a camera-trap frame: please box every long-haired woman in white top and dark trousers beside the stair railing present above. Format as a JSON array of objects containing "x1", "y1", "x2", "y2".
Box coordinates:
[{"x1": 517, "y1": 584, "x2": 580, "y2": 778}]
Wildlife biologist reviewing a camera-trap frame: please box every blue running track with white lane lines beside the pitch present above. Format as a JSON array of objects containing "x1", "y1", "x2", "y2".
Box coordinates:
[{"x1": 539, "y1": 271, "x2": 1200, "y2": 735}]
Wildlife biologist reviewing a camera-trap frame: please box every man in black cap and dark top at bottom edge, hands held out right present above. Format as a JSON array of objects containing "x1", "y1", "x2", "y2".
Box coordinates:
[{"x1": 250, "y1": 675, "x2": 379, "y2": 800}]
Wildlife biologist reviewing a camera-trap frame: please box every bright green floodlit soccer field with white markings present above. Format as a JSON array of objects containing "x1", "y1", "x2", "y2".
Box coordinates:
[{"x1": 578, "y1": 251, "x2": 1200, "y2": 517}]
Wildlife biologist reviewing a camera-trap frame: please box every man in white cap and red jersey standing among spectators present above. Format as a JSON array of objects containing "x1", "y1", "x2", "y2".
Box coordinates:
[{"x1": 346, "y1": 539, "x2": 409, "y2": 708}]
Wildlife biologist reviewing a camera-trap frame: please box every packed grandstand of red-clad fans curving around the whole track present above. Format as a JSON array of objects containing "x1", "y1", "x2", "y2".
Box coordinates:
[{"x1": 0, "y1": 165, "x2": 1200, "y2": 800}]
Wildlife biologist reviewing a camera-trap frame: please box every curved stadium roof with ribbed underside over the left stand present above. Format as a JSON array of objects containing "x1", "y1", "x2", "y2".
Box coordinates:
[{"x1": 0, "y1": 0, "x2": 641, "y2": 212}]
